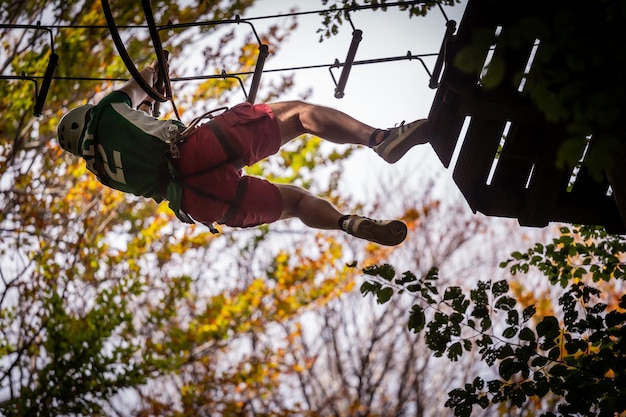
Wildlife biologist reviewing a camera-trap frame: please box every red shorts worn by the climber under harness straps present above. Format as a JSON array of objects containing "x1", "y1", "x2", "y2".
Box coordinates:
[{"x1": 176, "y1": 103, "x2": 282, "y2": 227}]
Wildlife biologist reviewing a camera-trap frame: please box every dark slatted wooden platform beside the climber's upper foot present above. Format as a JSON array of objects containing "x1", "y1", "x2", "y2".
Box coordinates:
[{"x1": 429, "y1": 0, "x2": 626, "y2": 234}]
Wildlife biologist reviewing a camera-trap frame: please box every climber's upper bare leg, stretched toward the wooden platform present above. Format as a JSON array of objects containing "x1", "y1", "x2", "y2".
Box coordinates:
[{"x1": 269, "y1": 101, "x2": 382, "y2": 146}]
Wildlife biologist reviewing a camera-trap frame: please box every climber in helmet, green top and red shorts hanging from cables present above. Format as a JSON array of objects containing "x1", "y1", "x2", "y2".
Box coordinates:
[{"x1": 58, "y1": 60, "x2": 427, "y2": 246}]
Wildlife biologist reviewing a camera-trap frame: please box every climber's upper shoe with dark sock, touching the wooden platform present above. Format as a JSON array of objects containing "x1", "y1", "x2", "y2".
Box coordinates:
[{"x1": 372, "y1": 119, "x2": 428, "y2": 164}]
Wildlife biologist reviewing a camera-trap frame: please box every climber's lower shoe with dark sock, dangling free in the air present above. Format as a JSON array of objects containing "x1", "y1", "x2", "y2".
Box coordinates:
[{"x1": 342, "y1": 215, "x2": 407, "y2": 246}]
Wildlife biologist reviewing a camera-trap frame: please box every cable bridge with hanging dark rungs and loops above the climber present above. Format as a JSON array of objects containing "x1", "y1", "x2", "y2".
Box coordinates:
[{"x1": 0, "y1": 0, "x2": 456, "y2": 116}]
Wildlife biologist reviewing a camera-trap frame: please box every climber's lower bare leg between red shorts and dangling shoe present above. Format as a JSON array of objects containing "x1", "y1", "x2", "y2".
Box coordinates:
[{"x1": 276, "y1": 184, "x2": 343, "y2": 230}]
